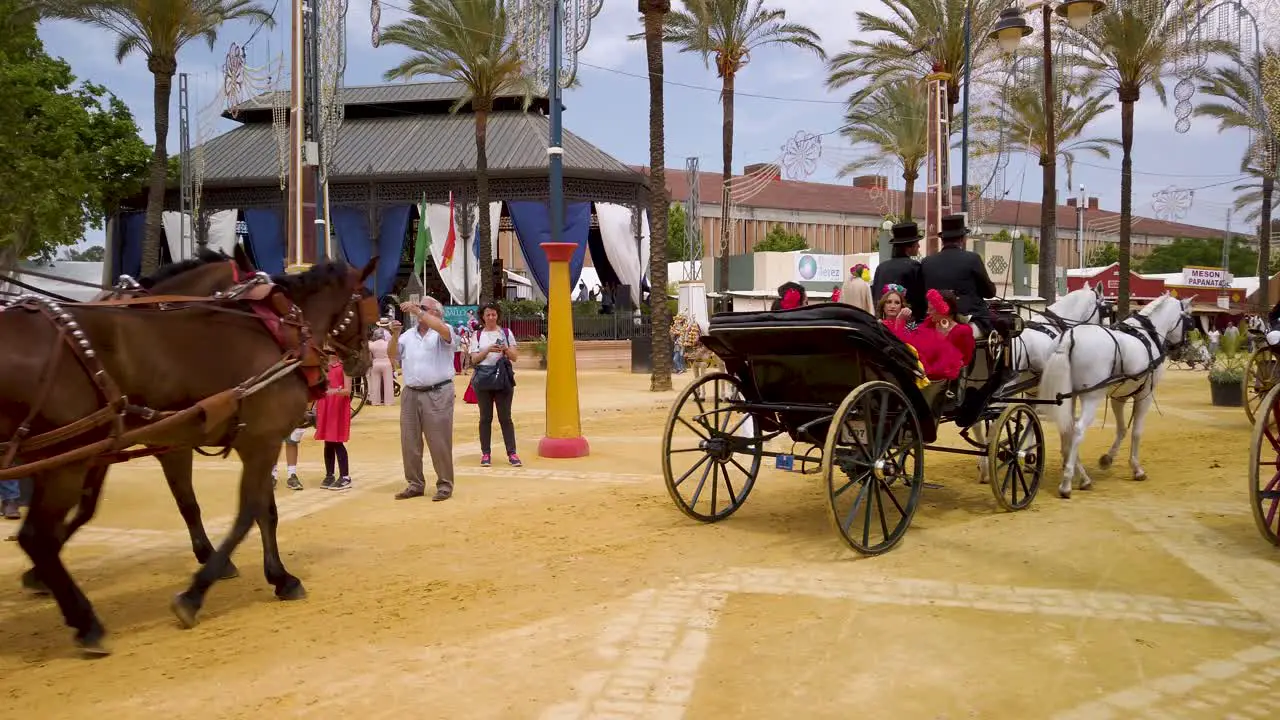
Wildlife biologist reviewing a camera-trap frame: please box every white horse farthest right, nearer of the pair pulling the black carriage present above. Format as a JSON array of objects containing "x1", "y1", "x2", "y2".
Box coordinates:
[{"x1": 1039, "y1": 293, "x2": 1192, "y2": 498}]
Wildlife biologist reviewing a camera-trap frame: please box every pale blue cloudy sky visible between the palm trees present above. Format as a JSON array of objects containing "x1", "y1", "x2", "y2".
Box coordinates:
[{"x1": 41, "y1": 0, "x2": 1269, "y2": 248}]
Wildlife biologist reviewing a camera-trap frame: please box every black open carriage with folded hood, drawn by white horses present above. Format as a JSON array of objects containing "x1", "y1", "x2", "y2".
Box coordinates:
[{"x1": 663, "y1": 304, "x2": 1044, "y2": 555}]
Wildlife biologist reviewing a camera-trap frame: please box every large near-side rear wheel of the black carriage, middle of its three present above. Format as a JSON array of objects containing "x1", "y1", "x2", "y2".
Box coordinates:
[{"x1": 822, "y1": 380, "x2": 924, "y2": 555}]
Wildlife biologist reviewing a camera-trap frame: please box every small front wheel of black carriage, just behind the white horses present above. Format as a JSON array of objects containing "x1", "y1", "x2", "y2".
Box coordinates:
[{"x1": 987, "y1": 404, "x2": 1044, "y2": 510}]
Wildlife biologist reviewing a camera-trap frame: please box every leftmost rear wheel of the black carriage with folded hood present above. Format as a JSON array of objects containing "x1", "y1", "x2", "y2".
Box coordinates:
[{"x1": 662, "y1": 373, "x2": 764, "y2": 523}]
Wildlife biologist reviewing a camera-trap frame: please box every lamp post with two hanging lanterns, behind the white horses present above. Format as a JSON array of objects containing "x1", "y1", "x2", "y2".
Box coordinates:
[{"x1": 988, "y1": 0, "x2": 1106, "y2": 305}]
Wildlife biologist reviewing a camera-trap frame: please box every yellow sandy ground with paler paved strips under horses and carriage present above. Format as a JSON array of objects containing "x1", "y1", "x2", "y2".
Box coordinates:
[{"x1": 0, "y1": 372, "x2": 1280, "y2": 720}]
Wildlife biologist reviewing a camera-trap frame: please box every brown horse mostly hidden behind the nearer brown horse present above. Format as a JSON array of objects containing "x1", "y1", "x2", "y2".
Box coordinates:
[{"x1": 22, "y1": 245, "x2": 257, "y2": 594}]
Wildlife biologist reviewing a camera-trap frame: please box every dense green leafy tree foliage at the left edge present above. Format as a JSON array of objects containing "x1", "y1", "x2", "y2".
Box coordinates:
[{"x1": 0, "y1": 0, "x2": 150, "y2": 266}]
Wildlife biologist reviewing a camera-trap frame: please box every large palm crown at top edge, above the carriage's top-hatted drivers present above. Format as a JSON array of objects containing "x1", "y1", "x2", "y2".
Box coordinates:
[{"x1": 827, "y1": 0, "x2": 1007, "y2": 114}]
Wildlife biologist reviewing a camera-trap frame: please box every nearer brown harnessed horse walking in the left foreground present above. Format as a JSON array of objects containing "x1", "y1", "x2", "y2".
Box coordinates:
[{"x1": 0, "y1": 260, "x2": 378, "y2": 653}]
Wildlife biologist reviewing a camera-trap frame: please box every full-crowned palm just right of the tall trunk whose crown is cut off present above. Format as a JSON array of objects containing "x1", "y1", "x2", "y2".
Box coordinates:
[{"x1": 632, "y1": 0, "x2": 827, "y2": 292}]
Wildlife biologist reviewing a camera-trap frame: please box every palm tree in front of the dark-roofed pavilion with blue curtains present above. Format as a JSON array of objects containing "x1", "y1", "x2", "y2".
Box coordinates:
[{"x1": 381, "y1": 0, "x2": 532, "y2": 302}]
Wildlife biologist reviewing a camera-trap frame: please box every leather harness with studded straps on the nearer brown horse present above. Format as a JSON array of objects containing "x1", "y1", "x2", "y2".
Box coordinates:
[{"x1": 0, "y1": 267, "x2": 376, "y2": 474}]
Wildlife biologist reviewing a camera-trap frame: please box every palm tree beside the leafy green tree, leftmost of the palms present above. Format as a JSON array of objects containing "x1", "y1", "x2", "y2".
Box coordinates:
[{"x1": 36, "y1": 0, "x2": 275, "y2": 274}]
